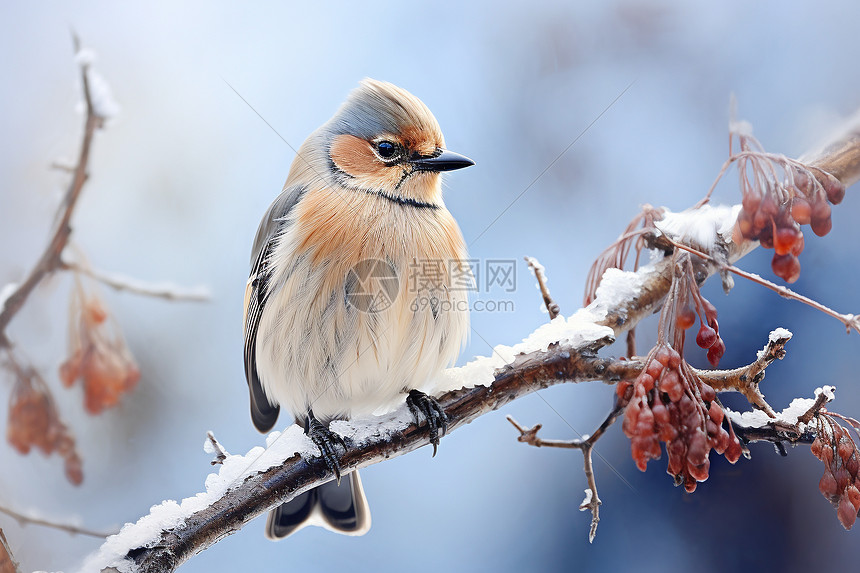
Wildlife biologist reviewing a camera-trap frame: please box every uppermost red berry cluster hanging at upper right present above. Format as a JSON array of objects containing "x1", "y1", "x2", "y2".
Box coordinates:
[{"x1": 735, "y1": 154, "x2": 845, "y2": 283}]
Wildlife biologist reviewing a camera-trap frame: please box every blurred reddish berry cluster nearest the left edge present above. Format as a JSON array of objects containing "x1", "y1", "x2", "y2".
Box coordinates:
[{"x1": 6, "y1": 369, "x2": 84, "y2": 485}]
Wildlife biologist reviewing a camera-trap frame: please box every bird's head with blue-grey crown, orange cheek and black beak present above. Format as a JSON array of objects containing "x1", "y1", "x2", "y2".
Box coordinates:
[{"x1": 321, "y1": 79, "x2": 474, "y2": 205}]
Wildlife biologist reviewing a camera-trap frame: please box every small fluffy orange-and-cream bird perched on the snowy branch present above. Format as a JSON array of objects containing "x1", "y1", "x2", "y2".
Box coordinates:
[{"x1": 244, "y1": 79, "x2": 474, "y2": 539}]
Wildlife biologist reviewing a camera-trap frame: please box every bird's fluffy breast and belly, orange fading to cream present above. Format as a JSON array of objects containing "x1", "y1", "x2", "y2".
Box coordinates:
[{"x1": 258, "y1": 185, "x2": 472, "y2": 417}]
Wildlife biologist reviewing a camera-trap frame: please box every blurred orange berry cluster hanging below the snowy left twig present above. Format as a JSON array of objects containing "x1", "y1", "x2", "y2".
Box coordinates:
[{"x1": 60, "y1": 290, "x2": 140, "y2": 414}]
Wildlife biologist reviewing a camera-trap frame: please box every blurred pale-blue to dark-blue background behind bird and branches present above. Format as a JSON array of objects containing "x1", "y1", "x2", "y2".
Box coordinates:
[{"x1": 0, "y1": 0, "x2": 860, "y2": 573}]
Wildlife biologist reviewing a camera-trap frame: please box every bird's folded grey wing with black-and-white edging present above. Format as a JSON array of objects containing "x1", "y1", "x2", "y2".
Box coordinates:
[{"x1": 245, "y1": 186, "x2": 305, "y2": 432}]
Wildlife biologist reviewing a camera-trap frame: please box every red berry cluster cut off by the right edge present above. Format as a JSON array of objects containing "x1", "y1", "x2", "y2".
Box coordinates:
[{"x1": 811, "y1": 413, "x2": 860, "y2": 529}]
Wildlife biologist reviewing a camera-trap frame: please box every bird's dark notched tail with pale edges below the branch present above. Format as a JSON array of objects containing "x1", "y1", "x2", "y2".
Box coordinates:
[{"x1": 266, "y1": 471, "x2": 370, "y2": 541}]
